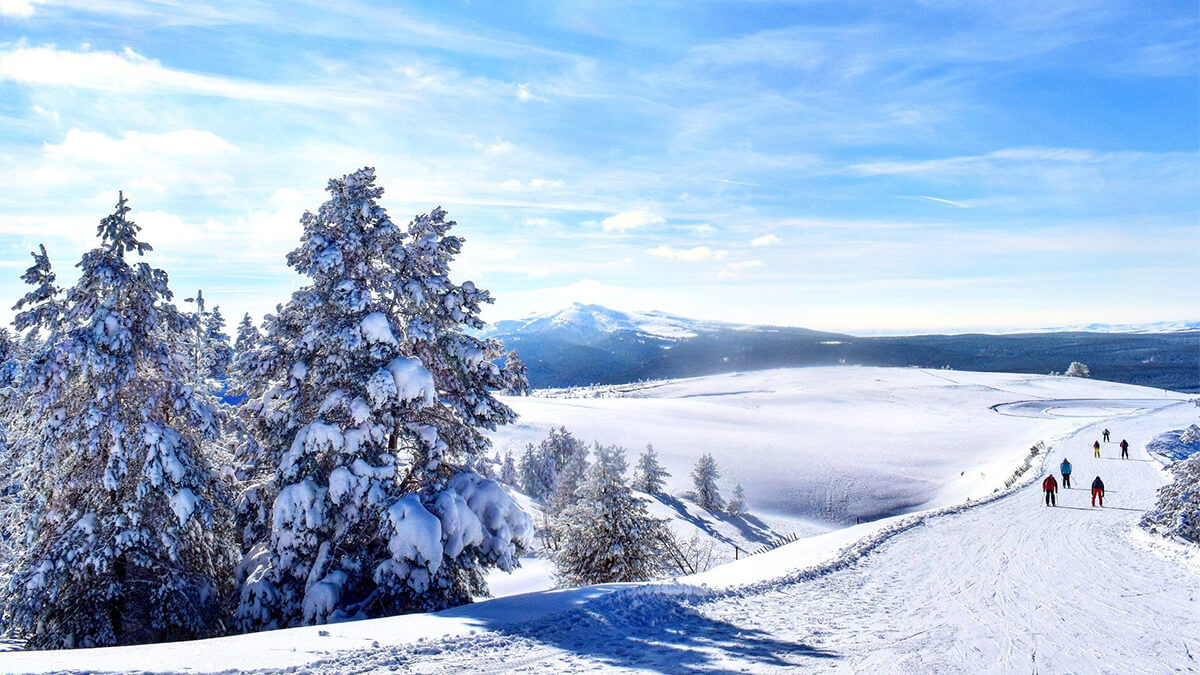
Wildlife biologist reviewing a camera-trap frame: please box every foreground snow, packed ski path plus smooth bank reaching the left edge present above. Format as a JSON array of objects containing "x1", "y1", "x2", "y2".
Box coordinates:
[{"x1": 0, "y1": 386, "x2": 1200, "y2": 673}]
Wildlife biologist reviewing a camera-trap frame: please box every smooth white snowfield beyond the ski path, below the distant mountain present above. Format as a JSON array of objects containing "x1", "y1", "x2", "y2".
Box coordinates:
[{"x1": 493, "y1": 368, "x2": 1178, "y2": 526}]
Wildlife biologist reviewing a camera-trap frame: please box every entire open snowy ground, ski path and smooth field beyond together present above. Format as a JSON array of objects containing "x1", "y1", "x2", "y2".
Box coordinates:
[{"x1": 0, "y1": 369, "x2": 1200, "y2": 673}]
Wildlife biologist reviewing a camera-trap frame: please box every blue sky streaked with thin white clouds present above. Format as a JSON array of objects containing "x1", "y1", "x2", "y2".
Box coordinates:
[{"x1": 0, "y1": 0, "x2": 1200, "y2": 333}]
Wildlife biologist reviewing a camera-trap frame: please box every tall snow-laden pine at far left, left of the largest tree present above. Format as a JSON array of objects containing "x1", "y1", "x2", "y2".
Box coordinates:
[{"x1": 5, "y1": 195, "x2": 233, "y2": 649}]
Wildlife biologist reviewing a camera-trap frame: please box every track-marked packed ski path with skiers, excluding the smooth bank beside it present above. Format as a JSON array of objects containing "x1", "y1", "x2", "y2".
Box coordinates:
[{"x1": 265, "y1": 401, "x2": 1200, "y2": 673}]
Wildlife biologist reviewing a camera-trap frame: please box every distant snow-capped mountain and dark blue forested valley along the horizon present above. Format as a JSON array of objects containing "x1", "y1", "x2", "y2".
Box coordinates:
[{"x1": 485, "y1": 304, "x2": 1200, "y2": 393}]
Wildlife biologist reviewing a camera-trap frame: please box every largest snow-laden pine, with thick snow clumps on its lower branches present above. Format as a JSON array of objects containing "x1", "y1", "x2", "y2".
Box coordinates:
[{"x1": 238, "y1": 168, "x2": 532, "y2": 629}]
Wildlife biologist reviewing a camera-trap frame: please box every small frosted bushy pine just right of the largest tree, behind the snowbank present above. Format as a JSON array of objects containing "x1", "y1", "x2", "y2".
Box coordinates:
[{"x1": 553, "y1": 446, "x2": 671, "y2": 586}]
